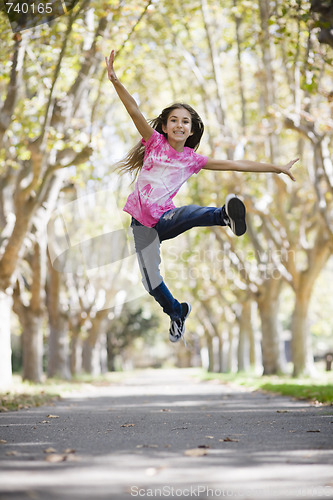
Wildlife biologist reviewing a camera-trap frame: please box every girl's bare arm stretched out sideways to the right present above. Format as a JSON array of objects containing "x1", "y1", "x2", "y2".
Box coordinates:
[{"x1": 204, "y1": 158, "x2": 299, "y2": 181}]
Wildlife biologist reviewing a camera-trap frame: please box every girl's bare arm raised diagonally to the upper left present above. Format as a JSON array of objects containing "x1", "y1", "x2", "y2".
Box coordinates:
[{"x1": 105, "y1": 50, "x2": 154, "y2": 141}]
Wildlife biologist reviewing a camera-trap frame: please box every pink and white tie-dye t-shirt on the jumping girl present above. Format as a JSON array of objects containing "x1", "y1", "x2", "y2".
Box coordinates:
[{"x1": 124, "y1": 130, "x2": 208, "y2": 227}]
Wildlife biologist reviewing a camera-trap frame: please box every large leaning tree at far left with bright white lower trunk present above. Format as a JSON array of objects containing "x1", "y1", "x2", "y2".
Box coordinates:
[{"x1": 0, "y1": 6, "x2": 106, "y2": 381}]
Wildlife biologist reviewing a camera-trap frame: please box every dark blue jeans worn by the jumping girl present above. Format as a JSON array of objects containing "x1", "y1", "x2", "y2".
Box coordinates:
[{"x1": 131, "y1": 205, "x2": 226, "y2": 320}]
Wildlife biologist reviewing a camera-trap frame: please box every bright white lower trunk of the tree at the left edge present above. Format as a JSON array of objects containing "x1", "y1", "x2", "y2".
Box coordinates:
[{"x1": 0, "y1": 291, "x2": 12, "y2": 391}]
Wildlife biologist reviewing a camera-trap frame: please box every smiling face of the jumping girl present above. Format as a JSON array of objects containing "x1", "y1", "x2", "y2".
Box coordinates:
[{"x1": 162, "y1": 108, "x2": 193, "y2": 149}]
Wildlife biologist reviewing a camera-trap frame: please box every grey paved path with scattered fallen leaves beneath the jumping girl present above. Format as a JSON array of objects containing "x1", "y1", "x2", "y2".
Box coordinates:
[{"x1": 0, "y1": 370, "x2": 333, "y2": 500}]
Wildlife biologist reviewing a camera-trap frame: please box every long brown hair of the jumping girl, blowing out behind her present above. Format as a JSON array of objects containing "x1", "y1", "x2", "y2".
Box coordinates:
[{"x1": 116, "y1": 102, "x2": 204, "y2": 180}]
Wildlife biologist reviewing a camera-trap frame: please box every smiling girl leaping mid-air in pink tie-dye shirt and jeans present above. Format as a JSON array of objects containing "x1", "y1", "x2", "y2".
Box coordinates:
[{"x1": 105, "y1": 50, "x2": 297, "y2": 342}]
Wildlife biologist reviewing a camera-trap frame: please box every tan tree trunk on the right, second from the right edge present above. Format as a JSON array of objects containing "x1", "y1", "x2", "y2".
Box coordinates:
[{"x1": 257, "y1": 278, "x2": 285, "y2": 375}]
